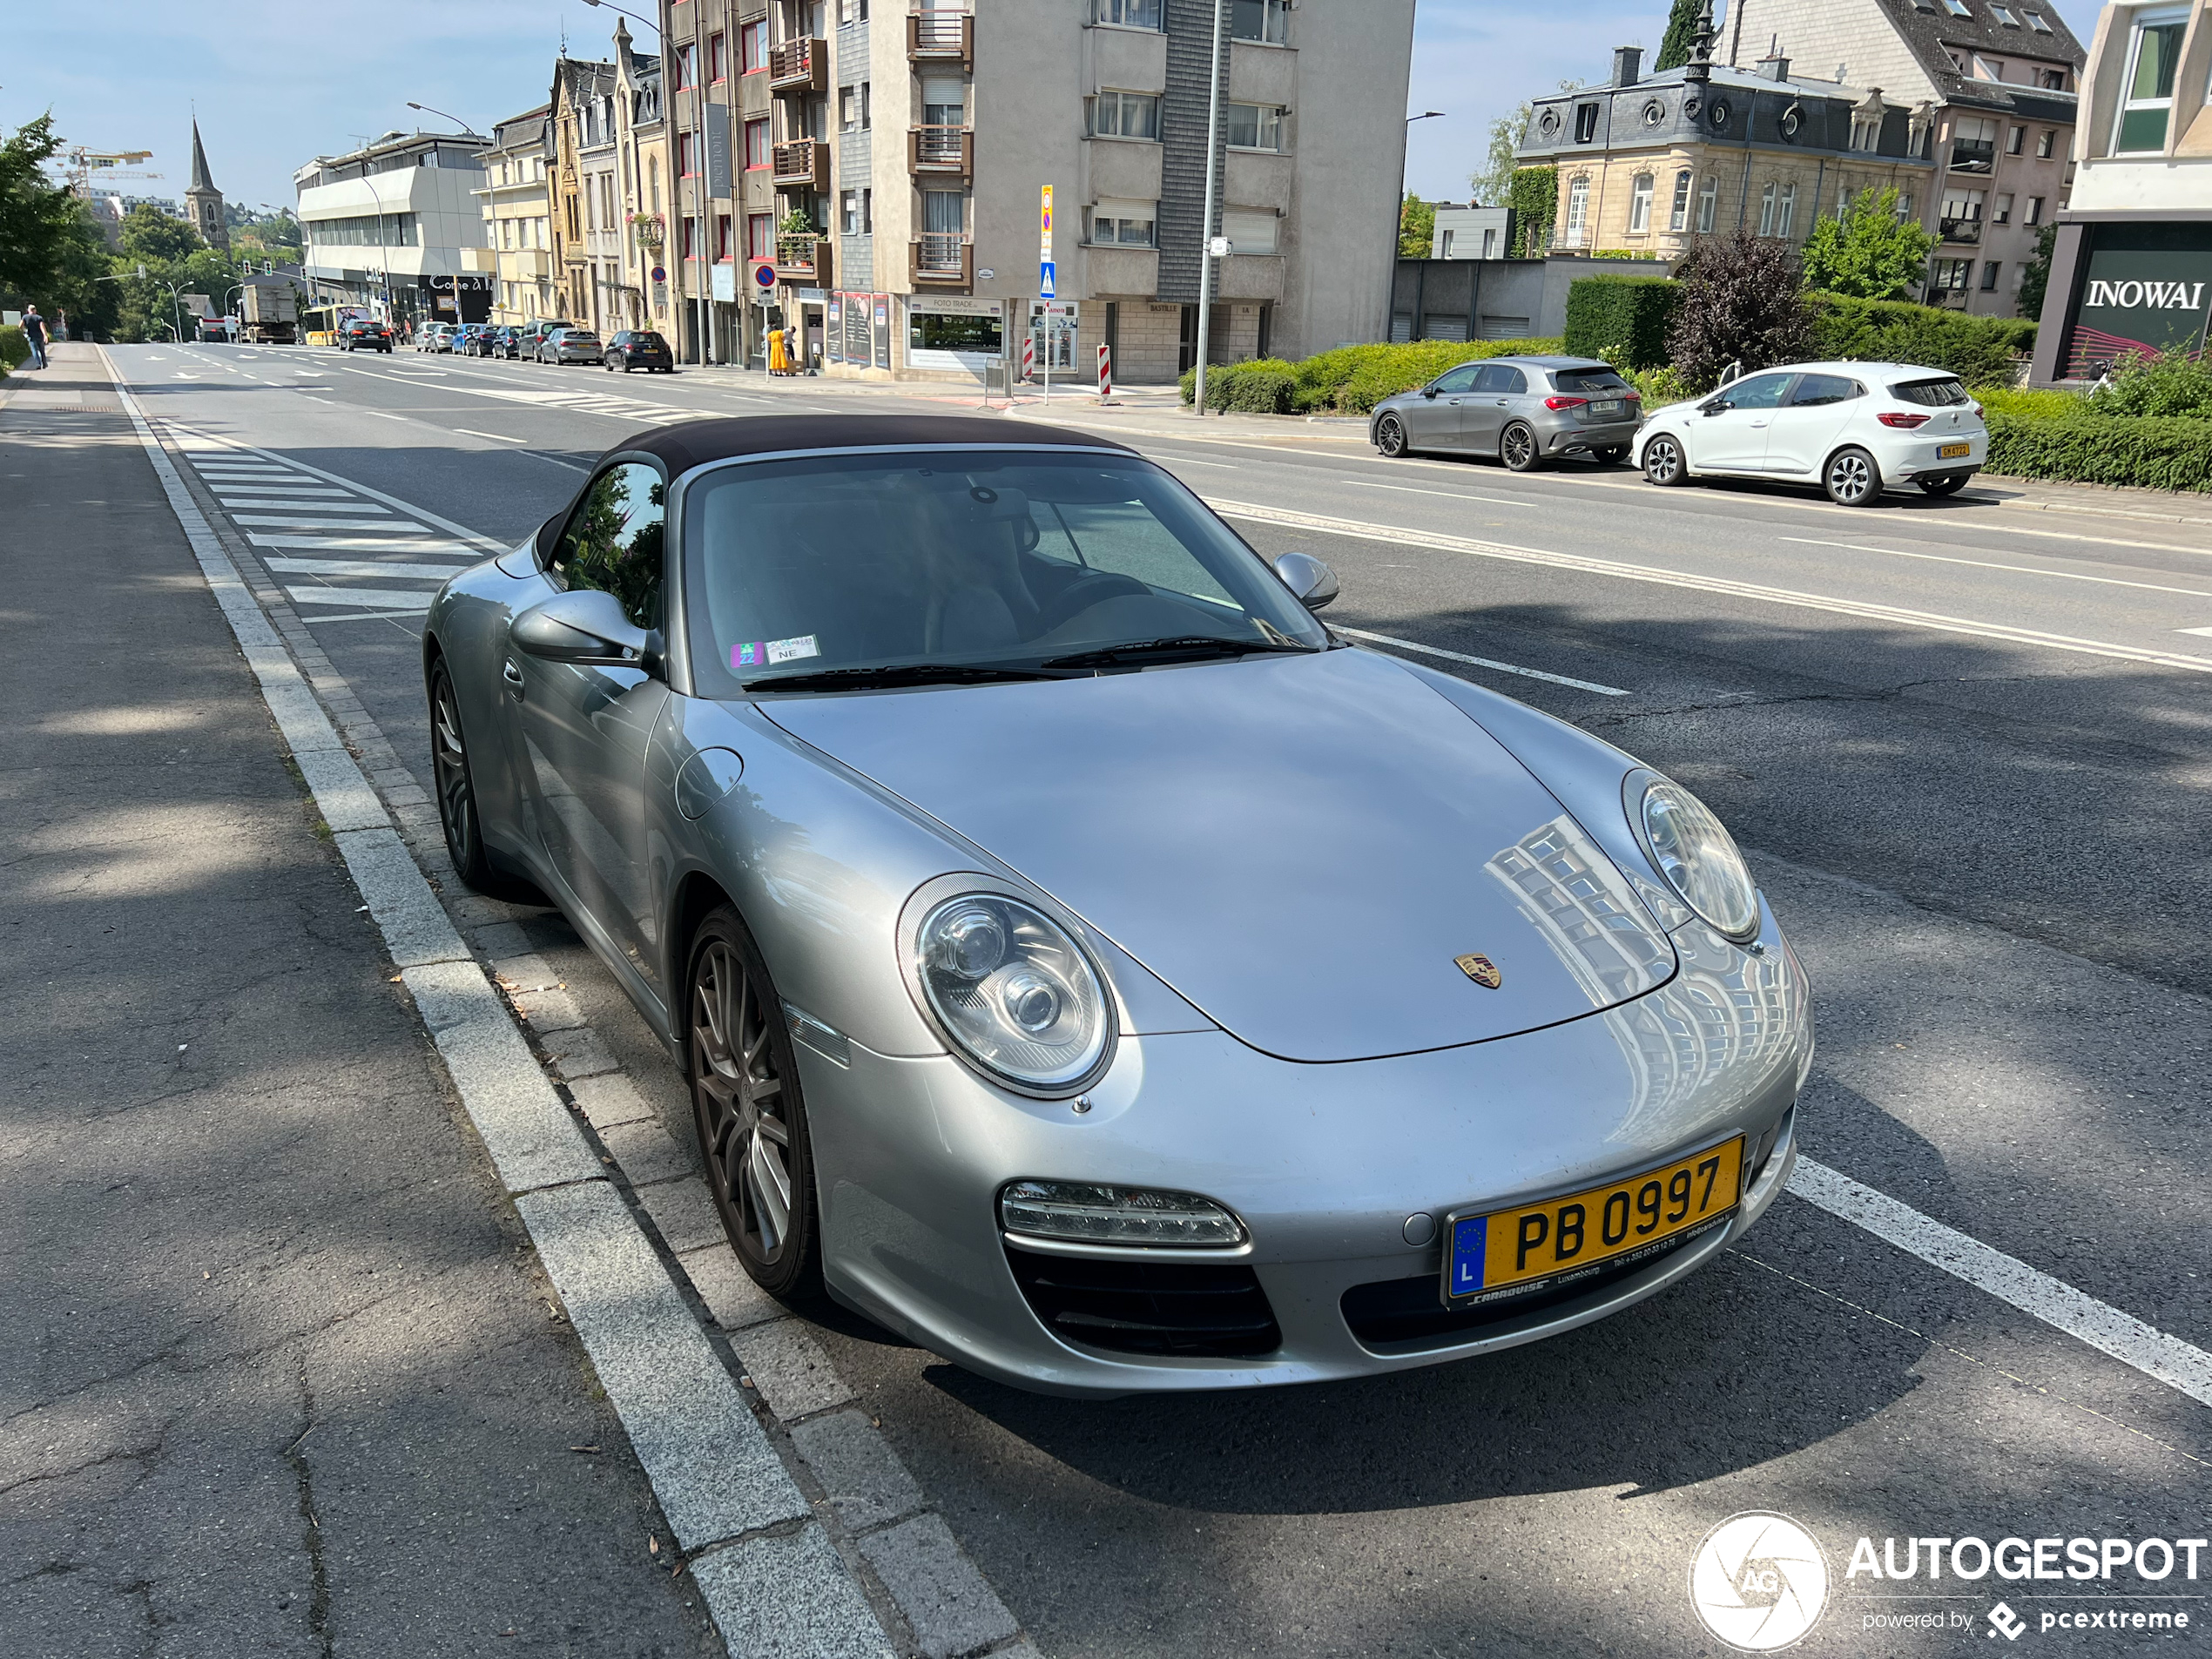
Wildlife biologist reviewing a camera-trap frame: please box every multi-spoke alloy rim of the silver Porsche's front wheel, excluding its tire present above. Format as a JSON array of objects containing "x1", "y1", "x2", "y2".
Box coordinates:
[{"x1": 690, "y1": 938, "x2": 794, "y2": 1267}]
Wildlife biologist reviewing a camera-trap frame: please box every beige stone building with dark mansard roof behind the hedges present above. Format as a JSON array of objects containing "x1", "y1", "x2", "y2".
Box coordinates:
[{"x1": 1513, "y1": 36, "x2": 1938, "y2": 261}]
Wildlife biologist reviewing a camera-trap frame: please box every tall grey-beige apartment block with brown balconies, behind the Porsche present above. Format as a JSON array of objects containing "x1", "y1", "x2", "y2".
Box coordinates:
[{"x1": 661, "y1": 0, "x2": 1413, "y2": 382}]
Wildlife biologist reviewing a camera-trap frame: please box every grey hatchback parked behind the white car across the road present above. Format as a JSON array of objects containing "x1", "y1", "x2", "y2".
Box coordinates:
[{"x1": 1367, "y1": 356, "x2": 1643, "y2": 474}]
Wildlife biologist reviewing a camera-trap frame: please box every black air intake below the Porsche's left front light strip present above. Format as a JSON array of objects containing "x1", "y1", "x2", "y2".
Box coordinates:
[{"x1": 1007, "y1": 1248, "x2": 1283, "y2": 1359}]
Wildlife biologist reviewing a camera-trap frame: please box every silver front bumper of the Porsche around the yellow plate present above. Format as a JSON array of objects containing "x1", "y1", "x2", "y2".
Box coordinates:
[{"x1": 799, "y1": 916, "x2": 1811, "y2": 1396}]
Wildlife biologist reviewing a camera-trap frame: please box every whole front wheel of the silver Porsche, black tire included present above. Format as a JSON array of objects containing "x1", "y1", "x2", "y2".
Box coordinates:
[{"x1": 684, "y1": 905, "x2": 820, "y2": 1298}]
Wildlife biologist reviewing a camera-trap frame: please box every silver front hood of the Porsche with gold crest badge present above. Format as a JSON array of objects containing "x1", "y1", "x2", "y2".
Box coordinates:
[{"x1": 759, "y1": 651, "x2": 1675, "y2": 1062}]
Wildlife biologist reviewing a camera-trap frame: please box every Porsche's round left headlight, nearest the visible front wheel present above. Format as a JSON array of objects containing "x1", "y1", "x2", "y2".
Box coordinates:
[{"x1": 916, "y1": 894, "x2": 1109, "y2": 1089}]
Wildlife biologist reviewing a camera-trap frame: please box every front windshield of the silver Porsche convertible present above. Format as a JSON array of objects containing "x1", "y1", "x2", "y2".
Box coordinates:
[{"x1": 684, "y1": 451, "x2": 1327, "y2": 697}]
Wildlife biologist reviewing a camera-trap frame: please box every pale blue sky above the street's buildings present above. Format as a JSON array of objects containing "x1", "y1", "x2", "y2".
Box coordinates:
[{"x1": 0, "y1": 0, "x2": 2097, "y2": 204}]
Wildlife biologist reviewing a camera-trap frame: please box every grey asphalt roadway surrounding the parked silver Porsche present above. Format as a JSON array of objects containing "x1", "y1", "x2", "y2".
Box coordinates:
[{"x1": 86, "y1": 347, "x2": 2212, "y2": 1655}]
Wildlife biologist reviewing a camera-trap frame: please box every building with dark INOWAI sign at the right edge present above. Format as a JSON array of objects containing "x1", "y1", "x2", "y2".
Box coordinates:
[{"x1": 2035, "y1": 0, "x2": 2212, "y2": 382}]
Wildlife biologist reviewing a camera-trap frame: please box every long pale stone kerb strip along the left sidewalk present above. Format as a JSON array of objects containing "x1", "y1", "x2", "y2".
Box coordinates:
[{"x1": 108, "y1": 358, "x2": 889, "y2": 1659}]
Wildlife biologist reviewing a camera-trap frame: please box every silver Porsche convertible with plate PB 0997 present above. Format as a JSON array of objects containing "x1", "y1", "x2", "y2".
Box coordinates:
[{"x1": 422, "y1": 416, "x2": 1811, "y2": 1396}]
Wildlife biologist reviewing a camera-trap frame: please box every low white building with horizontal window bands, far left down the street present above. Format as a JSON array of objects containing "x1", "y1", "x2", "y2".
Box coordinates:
[{"x1": 292, "y1": 132, "x2": 493, "y2": 323}]
